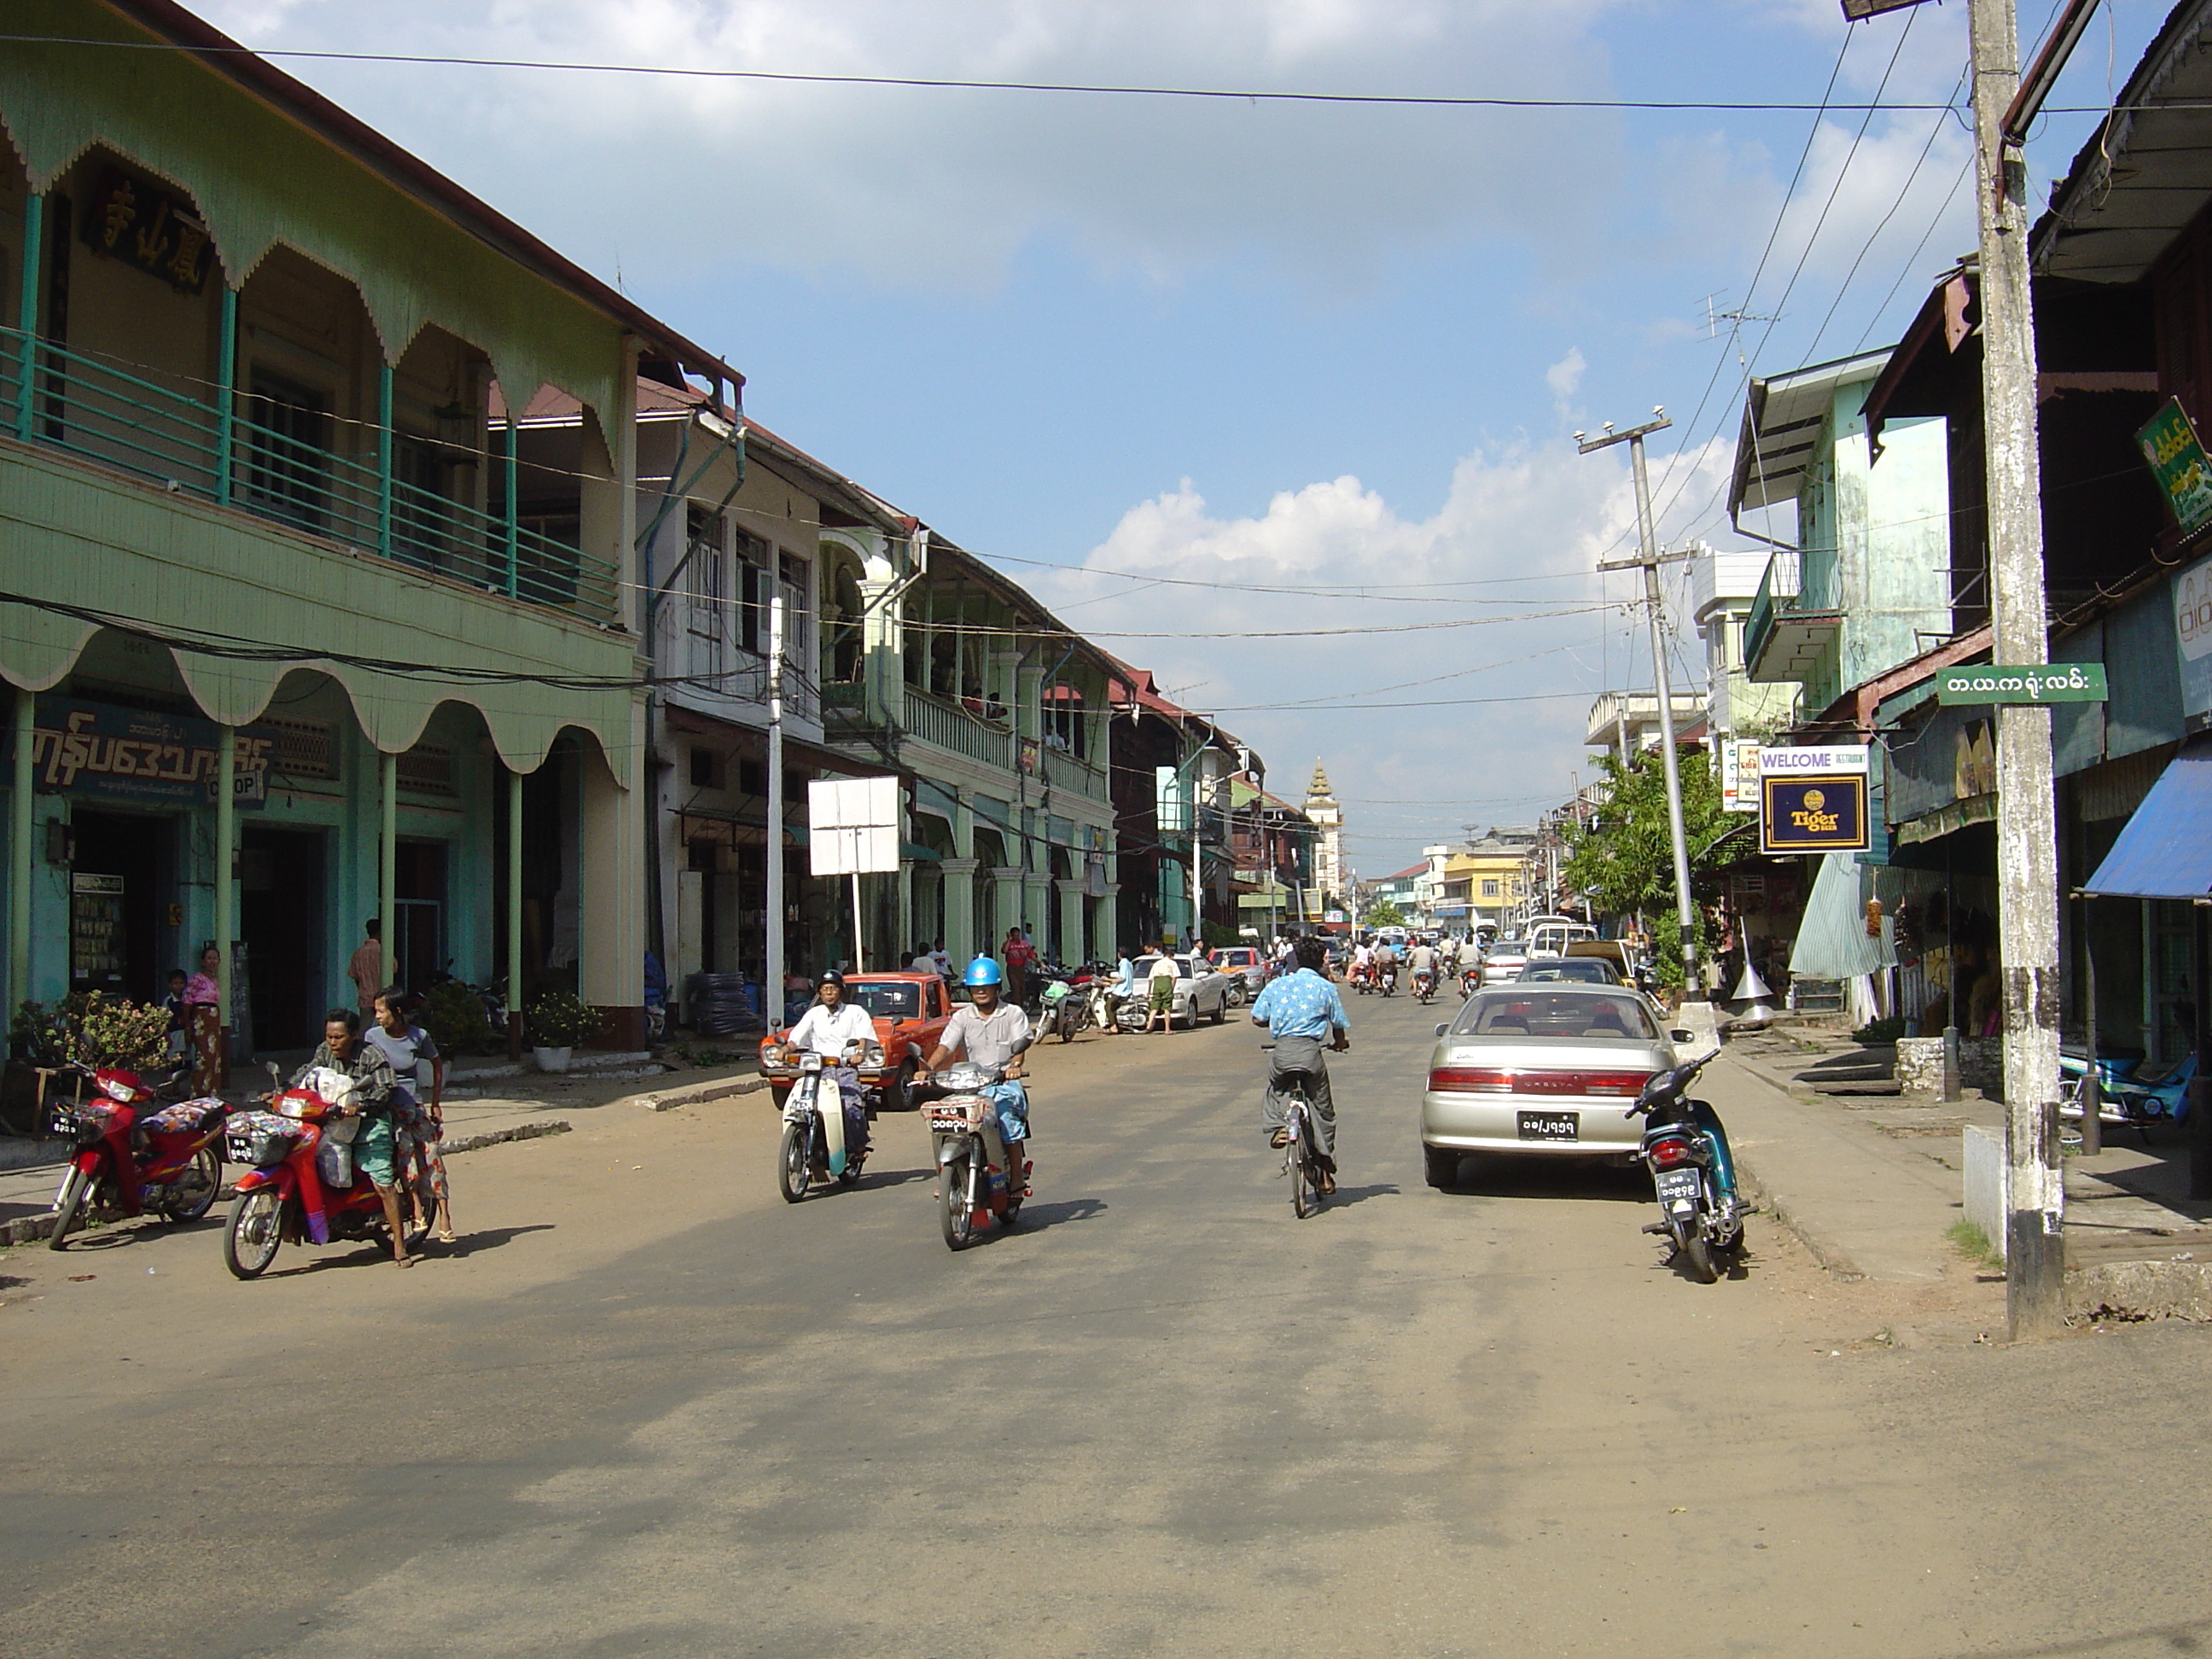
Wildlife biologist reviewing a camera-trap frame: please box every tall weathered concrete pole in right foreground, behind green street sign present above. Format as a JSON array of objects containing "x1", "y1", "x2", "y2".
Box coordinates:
[{"x1": 1842, "y1": 0, "x2": 2095, "y2": 1341}]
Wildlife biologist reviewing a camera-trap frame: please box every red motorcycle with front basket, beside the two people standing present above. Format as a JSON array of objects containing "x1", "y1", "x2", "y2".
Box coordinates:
[{"x1": 224, "y1": 1064, "x2": 416, "y2": 1278}]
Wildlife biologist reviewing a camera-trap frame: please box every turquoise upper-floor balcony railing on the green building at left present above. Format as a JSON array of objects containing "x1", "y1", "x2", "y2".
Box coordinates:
[{"x1": 0, "y1": 328, "x2": 620, "y2": 621}]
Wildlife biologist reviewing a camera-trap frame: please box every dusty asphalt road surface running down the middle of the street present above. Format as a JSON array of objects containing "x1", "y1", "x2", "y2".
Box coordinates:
[{"x1": 0, "y1": 998, "x2": 2212, "y2": 1659}]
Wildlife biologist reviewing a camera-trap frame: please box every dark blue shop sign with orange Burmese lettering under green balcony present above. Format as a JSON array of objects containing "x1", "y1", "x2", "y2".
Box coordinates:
[{"x1": 12, "y1": 696, "x2": 276, "y2": 807}]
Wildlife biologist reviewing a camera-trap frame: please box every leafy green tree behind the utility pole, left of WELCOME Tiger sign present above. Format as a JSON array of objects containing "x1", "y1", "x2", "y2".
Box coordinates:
[{"x1": 1562, "y1": 743, "x2": 1743, "y2": 989}]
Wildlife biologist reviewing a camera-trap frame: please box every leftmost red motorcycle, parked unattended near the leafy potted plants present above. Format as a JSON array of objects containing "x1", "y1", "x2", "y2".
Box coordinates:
[{"x1": 46, "y1": 1068, "x2": 230, "y2": 1249}]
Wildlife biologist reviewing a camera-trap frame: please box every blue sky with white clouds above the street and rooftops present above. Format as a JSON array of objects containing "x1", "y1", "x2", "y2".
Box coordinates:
[{"x1": 203, "y1": 0, "x2": 2166, "y2": 876}]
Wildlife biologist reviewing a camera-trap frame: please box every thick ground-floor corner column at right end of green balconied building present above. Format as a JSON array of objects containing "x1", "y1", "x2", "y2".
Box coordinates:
[{"x1": 578, "y1": 703, "x2": 645, "y2": 1049}]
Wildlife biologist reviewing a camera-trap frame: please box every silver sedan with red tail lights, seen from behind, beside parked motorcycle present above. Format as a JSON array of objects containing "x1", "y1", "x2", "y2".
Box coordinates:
[{"x1": 1420, "y1": 982, "x2": 1674, "y2": 1185}]
